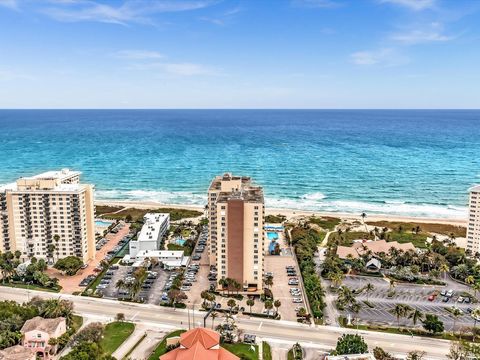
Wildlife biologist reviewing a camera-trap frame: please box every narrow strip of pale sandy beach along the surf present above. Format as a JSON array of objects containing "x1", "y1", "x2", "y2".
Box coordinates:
[{"x1": 95, "y1": 200, "x2": 467, "y2": 227}]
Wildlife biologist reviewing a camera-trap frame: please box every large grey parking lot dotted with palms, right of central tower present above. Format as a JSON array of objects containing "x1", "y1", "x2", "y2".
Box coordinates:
[{"x1": 336, "y1": 276, "x2": 478, "y2": 330}]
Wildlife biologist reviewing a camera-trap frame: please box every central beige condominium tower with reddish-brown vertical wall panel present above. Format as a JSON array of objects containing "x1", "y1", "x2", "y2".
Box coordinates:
[{"x1": 208, "y1": 174, "x2": 265, "y2": 292}]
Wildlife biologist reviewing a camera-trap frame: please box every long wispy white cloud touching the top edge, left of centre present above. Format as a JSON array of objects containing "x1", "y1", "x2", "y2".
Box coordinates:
[{"x1": 43, "y1": 0, "x2": 218, "y2": 25}]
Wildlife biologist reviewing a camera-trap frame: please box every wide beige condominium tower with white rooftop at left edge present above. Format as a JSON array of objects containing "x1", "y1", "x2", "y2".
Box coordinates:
[{"x1": 0, "y1": 169, "x2": 95, "y2": 262}]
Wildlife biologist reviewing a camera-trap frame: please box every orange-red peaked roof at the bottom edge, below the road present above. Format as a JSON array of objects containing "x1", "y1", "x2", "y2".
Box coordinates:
[{"x1": 160, "y1": 328, "x2": 240, "y2": 360}]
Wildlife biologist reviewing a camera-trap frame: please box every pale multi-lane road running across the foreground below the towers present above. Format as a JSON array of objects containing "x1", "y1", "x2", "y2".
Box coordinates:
[{"x1": 0, "y1": 287, "x2": 450, "y2": 360}]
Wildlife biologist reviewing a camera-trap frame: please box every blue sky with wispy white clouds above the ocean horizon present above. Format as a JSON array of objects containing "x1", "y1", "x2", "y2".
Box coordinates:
[{"x1": 0, "y1": 0, "x2": 480, "y2": 108}]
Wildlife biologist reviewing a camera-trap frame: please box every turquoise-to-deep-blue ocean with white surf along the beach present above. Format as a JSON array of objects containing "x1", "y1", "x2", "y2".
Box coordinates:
[{"x1": 0, "y1": 110, "x2": 480, "y2": 218}]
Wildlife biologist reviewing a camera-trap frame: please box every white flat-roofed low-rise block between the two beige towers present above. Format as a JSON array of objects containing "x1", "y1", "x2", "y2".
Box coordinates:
[{"x1": 130, "y1": 213, "x2": 170, "y2": 258}]
